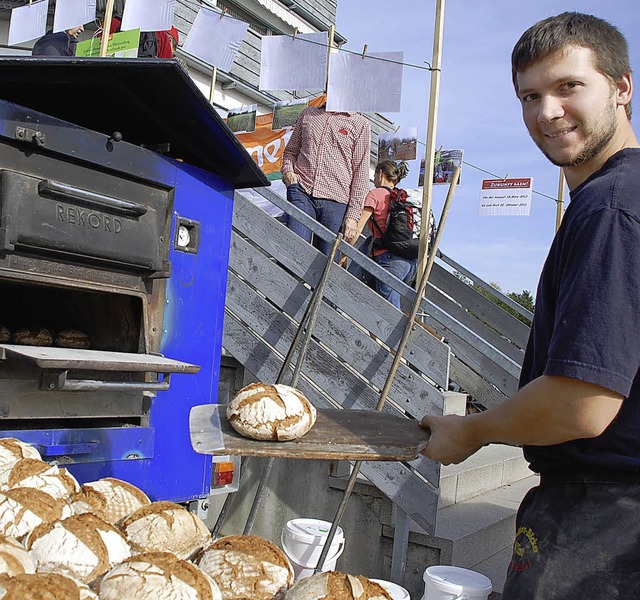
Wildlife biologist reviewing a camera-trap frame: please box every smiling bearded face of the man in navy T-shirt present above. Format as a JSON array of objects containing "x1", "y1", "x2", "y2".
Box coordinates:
[{"x1": 518, "y1": 47, "x2": 618, "y2": 167}]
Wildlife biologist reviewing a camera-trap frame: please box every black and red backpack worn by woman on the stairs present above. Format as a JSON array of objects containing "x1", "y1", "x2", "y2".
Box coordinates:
[{"x1": 371, "y1": 188, "x2": 433, "y2": 258}]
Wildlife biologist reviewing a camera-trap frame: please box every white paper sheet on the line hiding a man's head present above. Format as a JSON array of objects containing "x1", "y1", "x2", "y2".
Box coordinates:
[{"x1": 327, "y1": 52, "x2": 404, "y2": 113}]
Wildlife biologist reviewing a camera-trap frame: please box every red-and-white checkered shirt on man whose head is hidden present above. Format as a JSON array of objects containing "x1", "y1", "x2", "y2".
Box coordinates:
[{"x1": 282, "y1": 106, "x2": 371, "y2": 221}]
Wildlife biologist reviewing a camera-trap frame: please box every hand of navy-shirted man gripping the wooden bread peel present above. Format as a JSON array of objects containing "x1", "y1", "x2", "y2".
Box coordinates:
[{"x1": 420, "y1": 415, "x2": 482, "y2": 465}]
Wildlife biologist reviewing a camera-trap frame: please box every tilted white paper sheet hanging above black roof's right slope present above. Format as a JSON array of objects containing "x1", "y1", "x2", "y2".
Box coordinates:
[{"x1": 182, "y1": 7, "x2": 249, "y2": 71}]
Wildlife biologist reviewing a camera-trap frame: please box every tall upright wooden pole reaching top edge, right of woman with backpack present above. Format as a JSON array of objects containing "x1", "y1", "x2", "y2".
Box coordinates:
[{"x1": 418, "y1": 0, "x2": 445, "y2": 280}]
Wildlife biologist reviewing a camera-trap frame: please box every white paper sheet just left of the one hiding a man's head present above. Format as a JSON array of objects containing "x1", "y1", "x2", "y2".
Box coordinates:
[{"x1": 259, "y1": 31, "x2": 329, "y2": 91}]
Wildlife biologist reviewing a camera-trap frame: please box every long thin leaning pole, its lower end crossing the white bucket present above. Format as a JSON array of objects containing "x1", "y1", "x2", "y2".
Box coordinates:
[{"x1": 314, "y1": 167, "x2": 461, "y2": 573}]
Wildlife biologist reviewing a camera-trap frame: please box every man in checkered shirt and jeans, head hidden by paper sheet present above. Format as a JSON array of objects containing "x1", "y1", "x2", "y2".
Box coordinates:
[{"x1": 282, "y1": 106, "x2": 371, "y2": 254}]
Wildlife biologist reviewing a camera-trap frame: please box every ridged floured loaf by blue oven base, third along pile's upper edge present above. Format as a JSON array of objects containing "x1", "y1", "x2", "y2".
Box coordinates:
[{"x1": 71, "y1": 477, "x2": 151, "y2": 525}]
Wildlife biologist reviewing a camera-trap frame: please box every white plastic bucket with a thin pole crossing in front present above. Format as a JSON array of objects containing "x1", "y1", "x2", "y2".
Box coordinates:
[{"x1": 280, "y1": 519, "x2": 344, "y2": 581}]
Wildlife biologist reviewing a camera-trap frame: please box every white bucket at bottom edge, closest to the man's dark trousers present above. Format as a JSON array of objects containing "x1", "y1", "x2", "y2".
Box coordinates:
[{"x1": 422, "y1": 565, "x2": 493, "y2": 600}]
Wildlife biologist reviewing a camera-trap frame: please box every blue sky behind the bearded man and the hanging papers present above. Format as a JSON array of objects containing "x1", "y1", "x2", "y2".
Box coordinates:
[{"x1": 336, "y1": 0, "x2": 640, "y2": 295}]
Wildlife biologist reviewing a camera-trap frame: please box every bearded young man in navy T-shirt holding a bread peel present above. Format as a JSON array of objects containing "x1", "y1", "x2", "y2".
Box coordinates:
[{"x1": 422, "y1": 13, "x2": 640, "y2": 600}]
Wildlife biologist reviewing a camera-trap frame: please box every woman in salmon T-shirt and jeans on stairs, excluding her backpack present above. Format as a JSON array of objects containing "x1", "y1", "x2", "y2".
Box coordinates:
[{"x1": 342, "y1": 160, "x2": 418, "y2": 308}]
